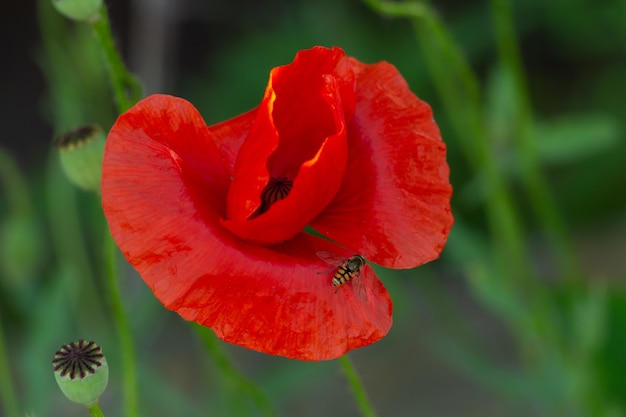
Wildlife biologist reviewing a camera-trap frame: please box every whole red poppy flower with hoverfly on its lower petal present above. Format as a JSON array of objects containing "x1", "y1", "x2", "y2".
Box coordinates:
[{"x1": 102, "y1": 47, "x2": 452, "y2": 360}]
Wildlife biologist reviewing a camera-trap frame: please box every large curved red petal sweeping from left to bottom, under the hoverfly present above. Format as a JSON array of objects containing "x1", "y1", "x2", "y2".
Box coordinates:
[{"x1": 102, "y1": 92, "x2": 392, "y2": 360}]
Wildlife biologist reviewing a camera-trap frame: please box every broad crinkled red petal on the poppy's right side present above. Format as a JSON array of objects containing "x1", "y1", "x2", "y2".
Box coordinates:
[{"x1": 311, "y1": 60, "x2": 453, "y2": 268}]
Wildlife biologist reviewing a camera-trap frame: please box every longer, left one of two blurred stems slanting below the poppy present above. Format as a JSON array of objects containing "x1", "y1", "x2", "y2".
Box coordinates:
[{"x1": 193, "y1": 325, "x2": 278, "y2": 417}]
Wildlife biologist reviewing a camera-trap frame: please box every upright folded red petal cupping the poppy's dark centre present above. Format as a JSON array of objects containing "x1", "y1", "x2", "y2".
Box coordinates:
[{"x1": 222, "y1": 48, "x2": 354, "y2": 245}]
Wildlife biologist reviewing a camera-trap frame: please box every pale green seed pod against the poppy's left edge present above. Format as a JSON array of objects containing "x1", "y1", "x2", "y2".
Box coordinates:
[{"x1": 54, "y1": 125, "x2": 105, "y2": 191}]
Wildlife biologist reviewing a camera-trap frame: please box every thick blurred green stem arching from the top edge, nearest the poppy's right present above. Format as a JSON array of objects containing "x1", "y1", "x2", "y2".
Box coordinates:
[{"x1": 365, "y1": 0, "x2": 558, "y2": 356}]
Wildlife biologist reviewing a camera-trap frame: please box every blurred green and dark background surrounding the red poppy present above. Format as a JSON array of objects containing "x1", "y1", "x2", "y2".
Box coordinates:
[{"x1": 0, "y1": 0, "x2": 626, "y2": 417}]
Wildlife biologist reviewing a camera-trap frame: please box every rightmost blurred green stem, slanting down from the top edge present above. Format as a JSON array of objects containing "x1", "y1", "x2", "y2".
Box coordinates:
[{"x1": 491, "y1": 0, "x2": 581, "y2": 279}]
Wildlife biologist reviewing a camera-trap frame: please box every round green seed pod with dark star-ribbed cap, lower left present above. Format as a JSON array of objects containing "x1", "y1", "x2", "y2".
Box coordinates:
[{"x1": 52, "y1": 339, "x2": 109, "y2": 408}]
